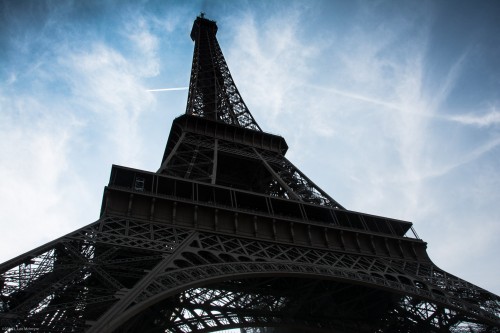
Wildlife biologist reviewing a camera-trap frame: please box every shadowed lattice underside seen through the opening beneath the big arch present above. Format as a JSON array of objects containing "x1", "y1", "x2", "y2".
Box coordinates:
[{"x1": 126, "y1": 277, "x2": 394, "y2": 332}]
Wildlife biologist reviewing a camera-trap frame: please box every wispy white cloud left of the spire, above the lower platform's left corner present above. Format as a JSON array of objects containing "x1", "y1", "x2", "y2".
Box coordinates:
[{"x1": 59, "y1": 43, "x2": 154, "y2": 163}]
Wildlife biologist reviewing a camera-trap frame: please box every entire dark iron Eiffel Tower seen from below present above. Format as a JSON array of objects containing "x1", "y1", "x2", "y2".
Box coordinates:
[{"x1": 0, "y1": 15, "x2": 500, "y2": 333}]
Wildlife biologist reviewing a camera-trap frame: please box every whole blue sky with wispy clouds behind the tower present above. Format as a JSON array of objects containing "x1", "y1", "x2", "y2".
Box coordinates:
[{"x1": 0, "y1": 0, "x2": 500, "y2": 295}]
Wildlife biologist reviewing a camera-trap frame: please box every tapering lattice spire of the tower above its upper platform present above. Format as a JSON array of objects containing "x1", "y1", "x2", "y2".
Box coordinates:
[{"x1": 186, "y1": 18, "x2": 261, "y2": 131}]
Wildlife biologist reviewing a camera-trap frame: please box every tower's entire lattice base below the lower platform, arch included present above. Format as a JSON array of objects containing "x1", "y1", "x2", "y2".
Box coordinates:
[{"x1": 0, "y1": 217, "x2": 500, "y2": 332}]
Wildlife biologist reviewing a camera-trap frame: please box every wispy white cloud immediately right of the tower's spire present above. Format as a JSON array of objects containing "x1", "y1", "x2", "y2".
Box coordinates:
[{"x1": 225, "y1": 6, "x2": 319, "y2": 128}]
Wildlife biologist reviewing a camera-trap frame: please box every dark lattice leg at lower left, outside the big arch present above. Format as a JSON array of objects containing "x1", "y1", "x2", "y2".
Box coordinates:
[{"x1": 0, "y1": 218, "x2": 193, "y2": 332}]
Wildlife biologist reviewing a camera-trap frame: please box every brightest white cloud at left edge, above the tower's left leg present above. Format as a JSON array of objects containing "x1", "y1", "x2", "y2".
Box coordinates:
[{"x1": 0, "y1": 94, "x2": 91, "y2": 261}]
